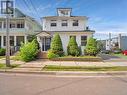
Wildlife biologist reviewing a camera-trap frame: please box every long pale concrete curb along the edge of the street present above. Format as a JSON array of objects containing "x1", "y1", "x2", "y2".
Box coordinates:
[{"x1": 0, "y1": 70, "x2": 127, "y2": 76}]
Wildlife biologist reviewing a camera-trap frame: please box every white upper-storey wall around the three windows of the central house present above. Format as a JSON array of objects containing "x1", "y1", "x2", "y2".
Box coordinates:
[{"x1": 43, "y1": 19, "x2": 87, "y2": 31}]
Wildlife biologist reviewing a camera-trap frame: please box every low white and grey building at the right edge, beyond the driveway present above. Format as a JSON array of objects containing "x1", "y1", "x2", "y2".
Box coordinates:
[{"x1": 105, "y1": 35, "x2": 127, "y2": 50}]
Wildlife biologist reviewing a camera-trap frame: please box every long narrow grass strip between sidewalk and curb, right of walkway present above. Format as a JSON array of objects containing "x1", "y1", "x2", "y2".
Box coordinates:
[{"x1": 42, "y1": 65, "x2": 127, "y2": 71}]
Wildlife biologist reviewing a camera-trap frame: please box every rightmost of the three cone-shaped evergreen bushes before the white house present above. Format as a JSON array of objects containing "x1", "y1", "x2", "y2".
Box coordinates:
[{"x1": 85, "y1": 37, "x2": 98, "y2": 56}]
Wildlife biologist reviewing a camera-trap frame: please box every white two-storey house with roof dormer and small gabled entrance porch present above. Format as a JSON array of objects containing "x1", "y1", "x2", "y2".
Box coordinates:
[{"x1": 38, "y1": 8, "x2": 95, "y2": 54}]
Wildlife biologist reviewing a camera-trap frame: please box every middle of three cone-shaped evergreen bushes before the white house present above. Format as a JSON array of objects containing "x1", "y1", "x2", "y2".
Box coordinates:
[{"x1": 67, "y1": 37, "x2": 80, "y2": 56}]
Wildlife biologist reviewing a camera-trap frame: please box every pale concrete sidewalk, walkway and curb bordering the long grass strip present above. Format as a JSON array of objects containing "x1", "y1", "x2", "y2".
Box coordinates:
[{"x1": 0, "y1": 59, "x2": 127, "y2": 75}]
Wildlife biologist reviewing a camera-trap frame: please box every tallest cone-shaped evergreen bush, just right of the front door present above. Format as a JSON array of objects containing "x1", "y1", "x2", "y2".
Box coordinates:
[{"x1": 50, "y1": 34, "x2": 64, "y2": 56}]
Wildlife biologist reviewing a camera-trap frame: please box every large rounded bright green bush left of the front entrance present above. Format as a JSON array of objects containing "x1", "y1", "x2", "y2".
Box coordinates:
[{"x1": 20, "y1": 40, "x2": 38, "y2": 62}]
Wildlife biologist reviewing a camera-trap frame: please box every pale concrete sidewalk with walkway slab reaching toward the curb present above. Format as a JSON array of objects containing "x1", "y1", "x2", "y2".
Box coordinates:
[{"x1": 0, "y1": 59, "x2": 127, "y2": 71}]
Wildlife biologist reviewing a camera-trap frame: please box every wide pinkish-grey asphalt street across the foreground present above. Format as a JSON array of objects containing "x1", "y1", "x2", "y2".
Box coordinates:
[{"x1": 0, "y1": 73, "x2": 127, "y2": 95}]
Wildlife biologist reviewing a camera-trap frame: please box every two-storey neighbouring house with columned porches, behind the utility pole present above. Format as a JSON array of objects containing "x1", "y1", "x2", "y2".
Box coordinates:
[{"x1": 0, "y1": 9, "x2": 42, "y2": 50}]
